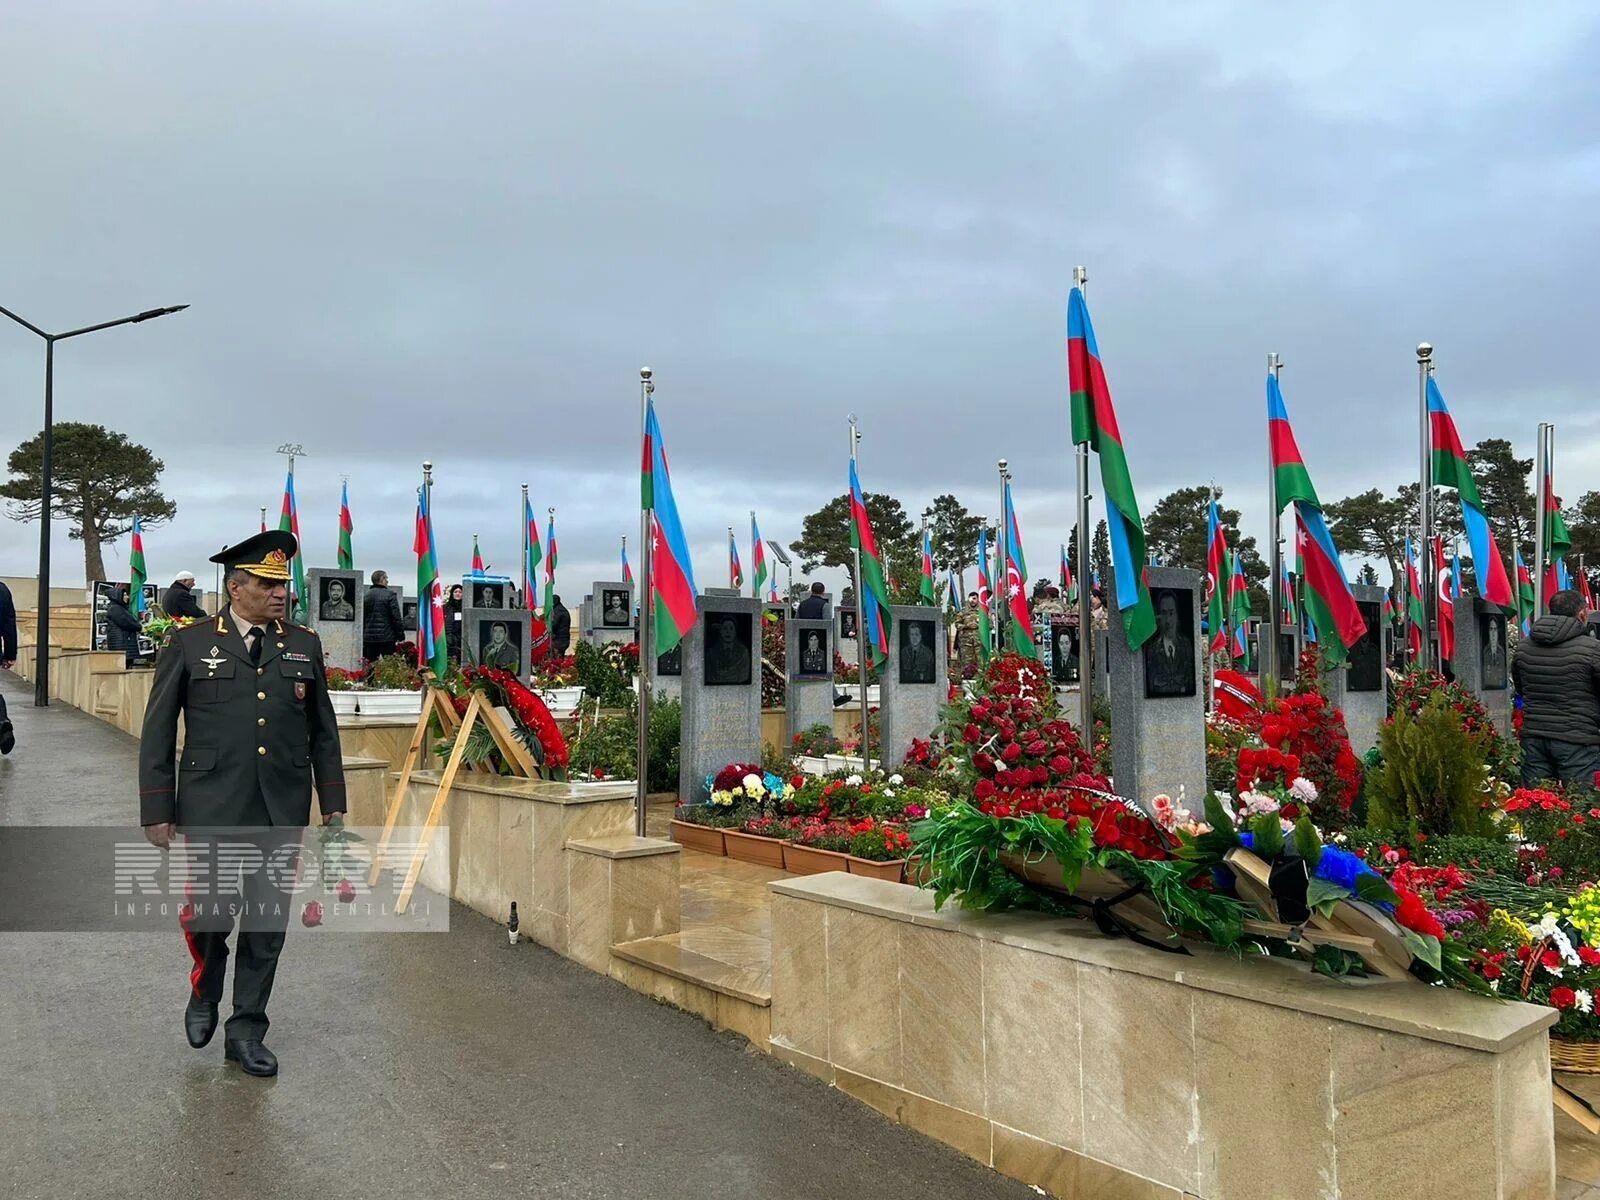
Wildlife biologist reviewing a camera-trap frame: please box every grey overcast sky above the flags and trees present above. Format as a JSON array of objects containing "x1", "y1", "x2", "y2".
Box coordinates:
[{"x1": 0, "y1": 0, "x2": 1600, "y2": 600}]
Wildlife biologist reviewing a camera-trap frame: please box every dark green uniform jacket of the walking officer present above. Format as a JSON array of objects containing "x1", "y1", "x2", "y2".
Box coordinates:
[{"x1": 139, "y1": 608, "x2": 344, "y2": 827}]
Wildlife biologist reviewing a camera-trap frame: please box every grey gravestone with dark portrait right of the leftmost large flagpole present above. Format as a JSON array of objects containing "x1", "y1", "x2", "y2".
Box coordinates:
[{"x1": 678, "y1": 589, "x2": 762, "y2": 805}]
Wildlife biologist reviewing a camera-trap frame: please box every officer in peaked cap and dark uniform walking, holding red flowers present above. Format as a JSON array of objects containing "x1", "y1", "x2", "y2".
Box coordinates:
[{"x1": 139, "y1": 530, "x2": 344, "y2": 1075}]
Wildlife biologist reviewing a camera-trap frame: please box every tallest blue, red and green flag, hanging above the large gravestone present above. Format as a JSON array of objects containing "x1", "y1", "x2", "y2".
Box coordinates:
[{"x1": 1067, "y1": 288, "x2": 1155, "y2": 650}]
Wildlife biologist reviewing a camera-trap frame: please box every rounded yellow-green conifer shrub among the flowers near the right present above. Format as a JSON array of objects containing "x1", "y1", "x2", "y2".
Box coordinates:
[{"x1": 1368, "y1": 690, "x2": 1488, "y2": 838}]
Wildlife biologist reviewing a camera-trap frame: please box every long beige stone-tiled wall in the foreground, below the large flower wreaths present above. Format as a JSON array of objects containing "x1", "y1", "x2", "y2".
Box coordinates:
[{"x1": 771, "y1": 874, "x2": 1555, "y2": 1200}]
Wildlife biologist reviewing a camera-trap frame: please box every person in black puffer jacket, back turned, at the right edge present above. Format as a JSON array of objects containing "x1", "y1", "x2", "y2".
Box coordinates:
[{"x1": 1510, "y1": 590, "x2": 1600, "y2": 787}]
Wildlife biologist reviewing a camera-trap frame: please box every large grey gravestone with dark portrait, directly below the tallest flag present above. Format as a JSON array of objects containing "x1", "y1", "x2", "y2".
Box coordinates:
[{"x1": 1106, "y1": 566, "x2": 1205, "y2": 811}]
